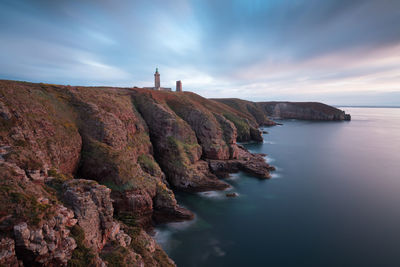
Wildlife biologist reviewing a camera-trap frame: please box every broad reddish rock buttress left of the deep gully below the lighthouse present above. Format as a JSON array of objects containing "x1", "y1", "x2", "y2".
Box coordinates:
[{"x1": 70, "y1": 88, "x2": 190, "y2": 227}]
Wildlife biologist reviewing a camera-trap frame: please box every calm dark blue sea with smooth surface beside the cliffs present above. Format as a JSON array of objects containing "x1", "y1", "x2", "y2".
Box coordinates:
[{"x1": 156, "y1": 108, "x2": 400, "y2": 267}]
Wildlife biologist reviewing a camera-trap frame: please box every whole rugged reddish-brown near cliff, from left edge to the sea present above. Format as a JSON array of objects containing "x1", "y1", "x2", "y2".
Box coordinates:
[{"x1": 0, "y1": 81, "x2": 273, "y2": 266}]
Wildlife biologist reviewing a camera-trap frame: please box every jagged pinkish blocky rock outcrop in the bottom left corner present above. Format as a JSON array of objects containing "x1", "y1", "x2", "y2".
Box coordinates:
[{"x1": 0, "y1": 160, "x2": 76, "y2": 266}]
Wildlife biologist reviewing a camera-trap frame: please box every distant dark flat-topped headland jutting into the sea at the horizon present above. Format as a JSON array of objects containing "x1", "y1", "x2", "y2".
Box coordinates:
[{"x1": 214, "y1": 98, "x2": 351, "y2": 122}]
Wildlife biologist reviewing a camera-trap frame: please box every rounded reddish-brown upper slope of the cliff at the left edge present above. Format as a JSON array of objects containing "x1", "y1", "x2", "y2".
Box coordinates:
[{"x1": 0, "y1": 84, "x2": 82, "y2": 176}]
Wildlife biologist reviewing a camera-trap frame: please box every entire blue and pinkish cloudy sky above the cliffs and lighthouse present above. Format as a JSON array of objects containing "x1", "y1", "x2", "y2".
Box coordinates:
[{"x1": 0, "y1": 0, "x2": 400, "y2": 106}]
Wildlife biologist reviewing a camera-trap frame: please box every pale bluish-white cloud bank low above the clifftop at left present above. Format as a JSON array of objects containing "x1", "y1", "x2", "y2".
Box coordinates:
[{"x1": 0, "y1": 34, "x2": 132, "y2": 85}]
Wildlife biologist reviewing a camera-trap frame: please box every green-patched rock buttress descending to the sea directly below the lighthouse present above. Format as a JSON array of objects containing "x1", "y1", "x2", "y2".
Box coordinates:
[{"x1": 135, "y1": 94, "x2": 228, "y2": 194}]
